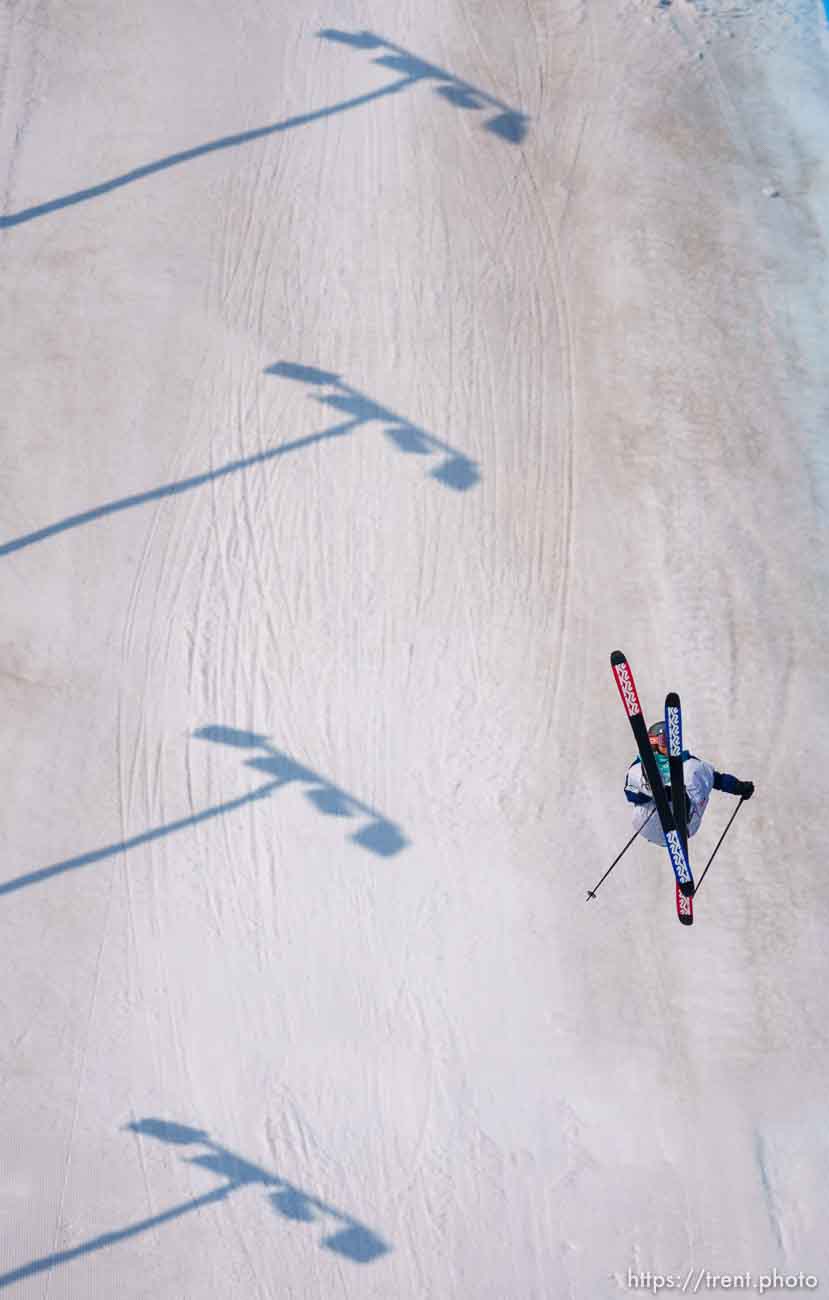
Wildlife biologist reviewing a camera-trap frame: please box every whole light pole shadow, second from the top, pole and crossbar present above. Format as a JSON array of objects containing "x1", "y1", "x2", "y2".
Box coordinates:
[{"x1": 0, "y1": 361, "x2": 481, "y2": 558}]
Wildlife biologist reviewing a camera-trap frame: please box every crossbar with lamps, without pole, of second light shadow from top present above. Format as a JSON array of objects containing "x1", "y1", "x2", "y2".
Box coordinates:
[{"x1": 262, "y1": 361, "x2": 481, "y2": 491}]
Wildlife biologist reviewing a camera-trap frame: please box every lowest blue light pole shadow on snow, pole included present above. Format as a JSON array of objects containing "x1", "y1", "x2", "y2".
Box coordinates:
[{"x1": 0, "y1": 1118, "x2": 391, "y2": 1288}]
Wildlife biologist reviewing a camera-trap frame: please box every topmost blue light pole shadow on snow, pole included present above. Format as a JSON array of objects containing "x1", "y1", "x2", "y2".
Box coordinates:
[{"x1": 0, "y1": 29, "x2": 528, "y2": 230}]
